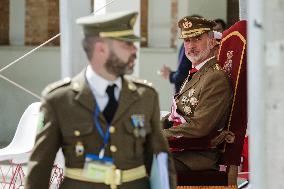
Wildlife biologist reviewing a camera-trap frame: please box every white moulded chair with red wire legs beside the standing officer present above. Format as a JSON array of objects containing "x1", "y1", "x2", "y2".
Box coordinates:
[{"x1": 0, "y1": 102, "x2": 41, "y2": 188}]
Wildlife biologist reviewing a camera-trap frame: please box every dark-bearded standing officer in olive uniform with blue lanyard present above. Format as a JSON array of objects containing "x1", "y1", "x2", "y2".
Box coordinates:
[{"x1": 25, "y1": 12, "x2": 176, "y2": 189}]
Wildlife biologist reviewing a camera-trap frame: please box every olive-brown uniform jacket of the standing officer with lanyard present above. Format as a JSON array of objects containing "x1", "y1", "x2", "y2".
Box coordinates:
[{"x1": 25, "y1": 72, "x2": 176, "y2": 189}]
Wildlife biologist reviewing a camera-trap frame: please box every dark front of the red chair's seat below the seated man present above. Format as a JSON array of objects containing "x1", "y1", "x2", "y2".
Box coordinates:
[{"x1": 177, "y1": 170, "x2": 228, "y2": 186}]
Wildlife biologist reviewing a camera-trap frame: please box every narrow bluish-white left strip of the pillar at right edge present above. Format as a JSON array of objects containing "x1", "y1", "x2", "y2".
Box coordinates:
[{"x1": 248, "y1": 0, "x2": 267, "y2": 189}]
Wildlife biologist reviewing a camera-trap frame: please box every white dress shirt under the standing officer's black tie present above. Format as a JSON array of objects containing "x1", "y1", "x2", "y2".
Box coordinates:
[{"x1": 86, "y1": 65, "x2": 122, "y2": 111}]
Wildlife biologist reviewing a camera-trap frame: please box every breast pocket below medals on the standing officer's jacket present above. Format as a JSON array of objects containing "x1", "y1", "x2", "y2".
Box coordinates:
[{"x1": 124, "y1": 122, "x2": 151, "y2": 158}]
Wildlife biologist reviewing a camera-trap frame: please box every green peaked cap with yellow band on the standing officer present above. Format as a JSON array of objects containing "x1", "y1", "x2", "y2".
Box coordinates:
[{"x1": 76, "y1": 11, "x2": 140, "y2": 42}]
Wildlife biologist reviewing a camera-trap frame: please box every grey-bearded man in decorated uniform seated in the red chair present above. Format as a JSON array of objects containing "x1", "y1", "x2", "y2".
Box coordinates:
[{"x1": 163, "y1": 17, "x2": 232, "y2": 171}]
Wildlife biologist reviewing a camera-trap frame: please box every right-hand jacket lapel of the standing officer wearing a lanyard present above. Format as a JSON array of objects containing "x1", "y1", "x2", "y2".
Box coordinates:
[{"x1": 112, "y1": 78, "x2": 140, "y2": 124}]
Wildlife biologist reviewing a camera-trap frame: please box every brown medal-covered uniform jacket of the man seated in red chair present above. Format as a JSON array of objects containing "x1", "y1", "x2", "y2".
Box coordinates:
[{"x1": 163, "y1": 58, "x2": 232, "y2": 170}]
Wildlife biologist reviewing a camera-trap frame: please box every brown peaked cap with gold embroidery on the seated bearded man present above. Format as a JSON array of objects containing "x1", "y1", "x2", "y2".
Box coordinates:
[{"x1": 178, "y1": 16, "x2": 216, "y2": 39}]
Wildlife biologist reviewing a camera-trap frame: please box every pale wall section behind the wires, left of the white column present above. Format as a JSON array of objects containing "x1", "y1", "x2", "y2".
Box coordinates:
[{"x1": 0, "y1": 46, "x2": 60, "y2": 146}]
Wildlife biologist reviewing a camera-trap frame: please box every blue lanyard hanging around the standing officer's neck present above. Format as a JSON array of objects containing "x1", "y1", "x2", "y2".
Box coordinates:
[{"x1": 93, "y1": 105, "x2": 110, "y2": 159}]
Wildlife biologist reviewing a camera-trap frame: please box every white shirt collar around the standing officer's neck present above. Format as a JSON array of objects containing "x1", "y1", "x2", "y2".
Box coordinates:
[{"x1": 86, "y1": 65, "x2": 122, "y2": 96}]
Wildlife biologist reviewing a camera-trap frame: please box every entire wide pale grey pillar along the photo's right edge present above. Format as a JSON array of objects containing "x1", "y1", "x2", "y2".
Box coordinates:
[{"x1": 248, "y1": 0, "x2": 284, "y2": 189}]
